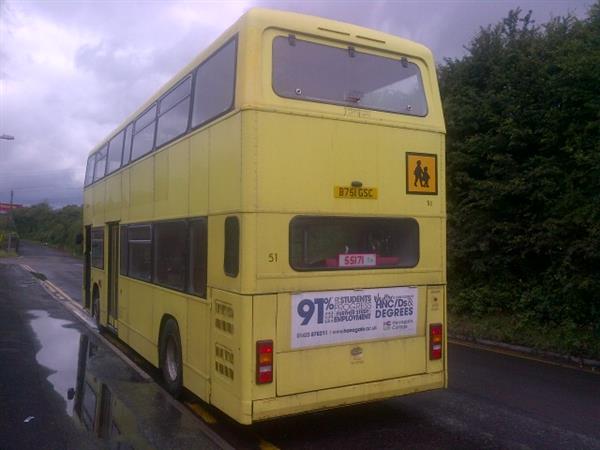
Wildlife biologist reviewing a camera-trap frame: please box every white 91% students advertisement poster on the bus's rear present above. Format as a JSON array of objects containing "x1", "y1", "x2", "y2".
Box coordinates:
[{"x1": 291, "y1": 287, "x2": 418, "y2": 348}]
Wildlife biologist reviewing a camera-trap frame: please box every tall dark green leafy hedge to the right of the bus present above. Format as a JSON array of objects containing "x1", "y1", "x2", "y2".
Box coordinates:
[{"x1": 439, "y1": 2, "x2": 600, "y2": 342}]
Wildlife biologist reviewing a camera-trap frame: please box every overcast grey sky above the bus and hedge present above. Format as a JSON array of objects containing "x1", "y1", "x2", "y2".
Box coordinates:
[{"x1": 0, "y1": 0, "x2": 593, "y2": 207}]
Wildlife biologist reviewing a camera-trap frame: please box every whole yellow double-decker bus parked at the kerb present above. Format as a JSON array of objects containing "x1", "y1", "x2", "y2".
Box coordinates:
[{"x1": 84, "y1": 9, "x2": 447, "y2": 424}]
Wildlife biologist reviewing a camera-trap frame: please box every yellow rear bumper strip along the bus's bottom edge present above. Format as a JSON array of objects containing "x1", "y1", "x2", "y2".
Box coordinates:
[{"x1": 252, "y1": 372, "x2": 446, "y2": 421}]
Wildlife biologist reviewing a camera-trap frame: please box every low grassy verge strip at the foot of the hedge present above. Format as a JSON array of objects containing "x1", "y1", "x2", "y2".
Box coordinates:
[{"x1": 448, "y1": 312, "x2": 600, "y2": 360}]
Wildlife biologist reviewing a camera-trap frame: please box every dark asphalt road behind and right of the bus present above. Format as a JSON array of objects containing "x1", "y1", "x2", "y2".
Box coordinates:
[{"x1": 251, "y1": 344, "x2": 600, "y2": 449}]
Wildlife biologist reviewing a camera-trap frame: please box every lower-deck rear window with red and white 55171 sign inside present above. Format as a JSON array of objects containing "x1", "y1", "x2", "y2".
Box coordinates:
[{"x1": 290, "y1": 216, "x2": 419, "y2": 270}]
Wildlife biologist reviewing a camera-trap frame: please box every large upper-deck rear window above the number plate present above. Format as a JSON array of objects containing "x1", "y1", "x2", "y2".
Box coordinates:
[{"x1": 273, "y1": 36, "x2": 427, "y2": 116}]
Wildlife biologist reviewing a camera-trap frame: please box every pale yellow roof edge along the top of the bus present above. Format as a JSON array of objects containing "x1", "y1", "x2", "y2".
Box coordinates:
[{"x1": 88, "y1": 8, "x2": 435, "y2": 155}]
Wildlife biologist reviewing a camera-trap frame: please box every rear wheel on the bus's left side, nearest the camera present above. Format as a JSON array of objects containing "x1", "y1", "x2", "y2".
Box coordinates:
[{"x1": 159, "y1": 319, "x2": 183, "y2": 397}]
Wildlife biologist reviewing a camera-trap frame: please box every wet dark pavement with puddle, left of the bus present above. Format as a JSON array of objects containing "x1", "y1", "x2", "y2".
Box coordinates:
[{"x1": 0, "y1": 264, "x2": 224, "y2": 450}]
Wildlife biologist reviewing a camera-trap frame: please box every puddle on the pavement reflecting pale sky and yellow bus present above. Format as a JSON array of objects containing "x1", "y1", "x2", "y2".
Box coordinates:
[{"x1": 29, "y1": 310, "x2": 217, "y2": 449}]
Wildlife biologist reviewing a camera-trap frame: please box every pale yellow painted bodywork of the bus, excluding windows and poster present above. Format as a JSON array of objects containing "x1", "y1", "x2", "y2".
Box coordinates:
[{"x1": 84, "y1": 9, "x2": 447, "y2": 424}]
